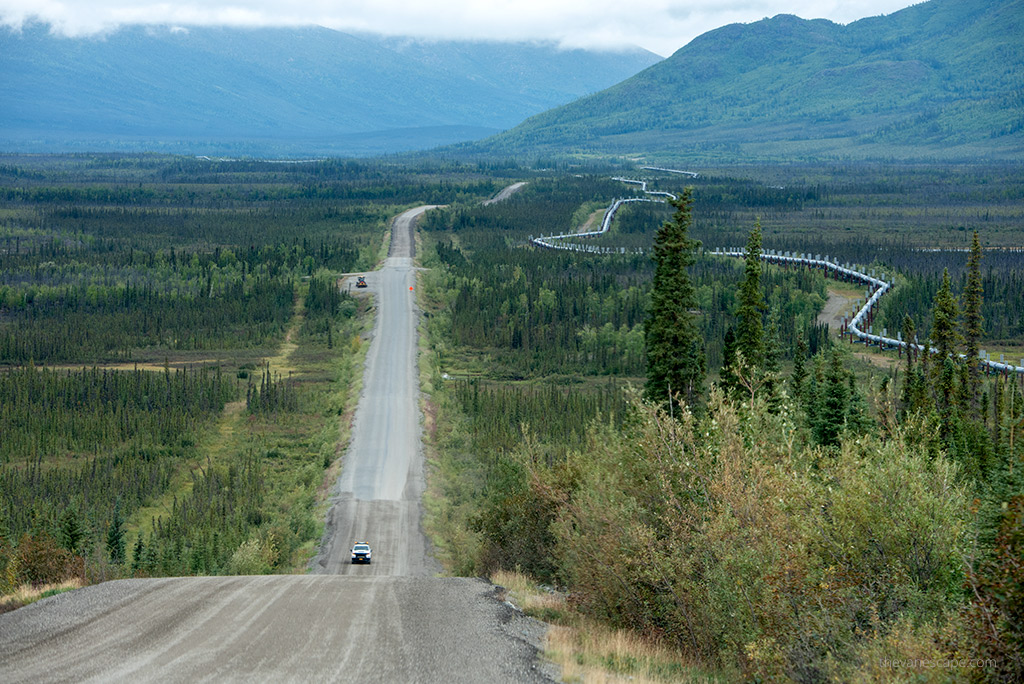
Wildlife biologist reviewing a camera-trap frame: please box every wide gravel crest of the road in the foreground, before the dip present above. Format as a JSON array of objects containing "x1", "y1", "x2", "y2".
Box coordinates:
[{"x1": 0, "y1": 575, "x2": 546, "y2": 682}]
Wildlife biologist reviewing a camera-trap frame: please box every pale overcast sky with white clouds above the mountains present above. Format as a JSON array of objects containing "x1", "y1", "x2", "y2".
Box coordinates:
[{"x1": 0, "y1": 0, "x2": 914, "y2": 56}]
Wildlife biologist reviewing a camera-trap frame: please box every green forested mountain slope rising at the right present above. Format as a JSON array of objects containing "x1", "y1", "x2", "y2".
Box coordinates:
[{"x1": 467, "y1": 0, "x2": 1024, "y2": 161}]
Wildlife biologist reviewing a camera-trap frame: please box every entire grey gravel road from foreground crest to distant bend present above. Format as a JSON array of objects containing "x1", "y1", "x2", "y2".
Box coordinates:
[{"x1": 0, "y1": 207, "x2": 550, "y2": 683}]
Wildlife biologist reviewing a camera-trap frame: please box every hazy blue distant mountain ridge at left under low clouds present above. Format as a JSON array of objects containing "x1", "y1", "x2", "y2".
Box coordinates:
[{"x1": 0, "y1": 25, "x2": 660, "y2": 154}]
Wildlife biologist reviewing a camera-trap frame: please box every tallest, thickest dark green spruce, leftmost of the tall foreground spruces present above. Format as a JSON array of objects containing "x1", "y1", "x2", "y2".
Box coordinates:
[{"x1": 644, "y1": 187, "x2": 707, "y2": 411}]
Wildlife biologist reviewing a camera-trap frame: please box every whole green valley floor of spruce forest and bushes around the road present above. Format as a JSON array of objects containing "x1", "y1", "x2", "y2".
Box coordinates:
[{"x1": 0, "y1": 156, "x2": 1024, "y2": 682}]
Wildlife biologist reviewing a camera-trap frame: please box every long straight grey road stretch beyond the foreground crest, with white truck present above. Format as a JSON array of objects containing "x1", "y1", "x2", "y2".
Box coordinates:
[{"x1": 313, "y1": 207, "x2": 439, "y2": 576}]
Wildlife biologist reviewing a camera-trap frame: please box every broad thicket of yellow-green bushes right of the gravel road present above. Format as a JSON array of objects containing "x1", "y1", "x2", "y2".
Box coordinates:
[{"x1": 552, "y1": 393, "x2": 968, "y2": 682}]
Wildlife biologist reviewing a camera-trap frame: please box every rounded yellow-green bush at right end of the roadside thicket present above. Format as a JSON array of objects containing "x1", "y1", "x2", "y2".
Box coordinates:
[{"x1": 814, "y1": 430, "x2": 968, "y2": 624}]
